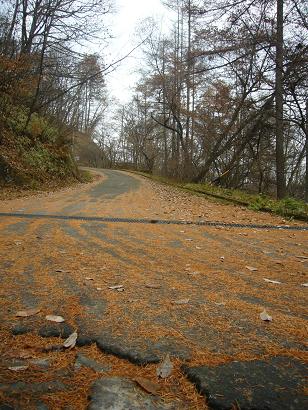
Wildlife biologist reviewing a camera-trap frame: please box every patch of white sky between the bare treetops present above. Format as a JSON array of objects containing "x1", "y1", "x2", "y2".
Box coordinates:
[{"x1": 105, "y1": 0, "x2": 170, "y2": 103}]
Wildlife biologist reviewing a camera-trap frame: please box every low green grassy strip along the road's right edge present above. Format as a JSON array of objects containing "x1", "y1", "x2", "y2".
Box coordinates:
[{"x1": 129, "y1": 171, "x2": 308, "y2": 222}]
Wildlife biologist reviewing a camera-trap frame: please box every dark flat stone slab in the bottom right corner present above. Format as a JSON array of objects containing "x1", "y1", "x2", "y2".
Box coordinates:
[{"x1": 183, "y1": 357, "x2": 308, "y2": 410}]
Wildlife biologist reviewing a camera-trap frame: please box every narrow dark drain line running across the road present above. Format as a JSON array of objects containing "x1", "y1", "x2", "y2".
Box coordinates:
[{"x1": 0, "y1": 212, "x2": 308, "y2": 231}]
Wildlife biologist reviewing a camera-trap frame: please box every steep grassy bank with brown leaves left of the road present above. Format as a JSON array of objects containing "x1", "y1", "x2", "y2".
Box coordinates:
[{"x1": 0, "y1": 102, "x2": 89, "y2": 191}]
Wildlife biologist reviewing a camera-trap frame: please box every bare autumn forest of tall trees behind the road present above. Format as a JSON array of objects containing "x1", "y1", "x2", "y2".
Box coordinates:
[{"x1": 0, "y1": 0, "x2": 308, "y2": 202}]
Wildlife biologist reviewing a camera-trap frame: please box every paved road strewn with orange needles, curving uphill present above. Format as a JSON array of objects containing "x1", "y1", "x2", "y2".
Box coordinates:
[{"x1": 0, "y1": 170, "x2": 308, "y2": 409}]
